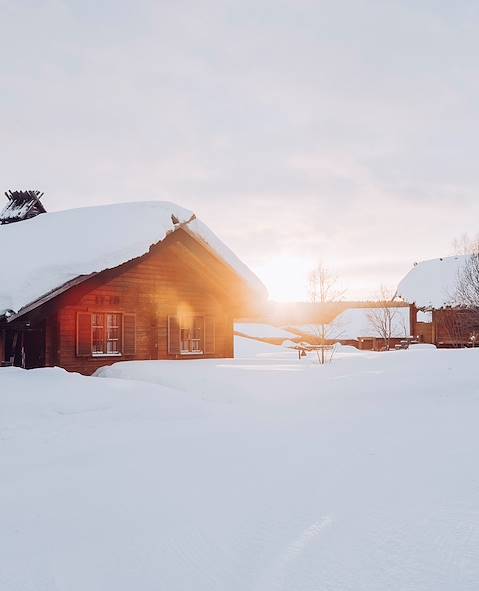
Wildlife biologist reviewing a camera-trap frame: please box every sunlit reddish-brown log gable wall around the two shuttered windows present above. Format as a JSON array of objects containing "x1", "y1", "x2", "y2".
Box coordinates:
[{"x1": 54, "y1": 244, "x2": 233, "y2": 374}]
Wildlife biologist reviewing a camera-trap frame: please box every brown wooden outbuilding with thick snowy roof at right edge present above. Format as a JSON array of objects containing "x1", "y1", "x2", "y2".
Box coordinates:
[{"x1": 396, "y1": 255, "x2": 479, "y2": 347}]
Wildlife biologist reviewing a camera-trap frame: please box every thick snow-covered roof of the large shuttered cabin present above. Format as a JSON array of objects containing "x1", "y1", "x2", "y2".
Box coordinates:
[{"x1": 0, "y1": 201, "x2": 266, "y2": 315}]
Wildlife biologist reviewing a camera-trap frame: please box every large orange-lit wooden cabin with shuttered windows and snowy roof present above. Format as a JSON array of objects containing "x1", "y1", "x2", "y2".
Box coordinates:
[{"x1": 0, "y1": 202, "x2": 266, "y2": 375}]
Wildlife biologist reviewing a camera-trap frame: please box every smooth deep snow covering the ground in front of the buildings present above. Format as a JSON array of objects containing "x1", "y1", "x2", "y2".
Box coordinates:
[{"x1": 0, "y1": 350, "x2": 479, "y2": 591}]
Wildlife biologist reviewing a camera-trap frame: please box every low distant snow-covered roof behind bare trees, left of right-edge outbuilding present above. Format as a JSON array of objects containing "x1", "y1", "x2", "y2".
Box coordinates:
[{"x1": 295, "y1": 306, "x2": 410, "y2": 341}]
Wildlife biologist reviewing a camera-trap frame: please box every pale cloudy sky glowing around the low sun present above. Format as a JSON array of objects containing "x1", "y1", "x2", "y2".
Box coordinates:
[{"x1": 0, "y1": 0, "x2": 479, "y2": 300}]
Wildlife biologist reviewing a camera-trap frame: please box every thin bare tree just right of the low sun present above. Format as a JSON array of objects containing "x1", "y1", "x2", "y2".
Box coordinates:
[{"x1": 309, "y1": 262, "x2": 344, "y2": 365}]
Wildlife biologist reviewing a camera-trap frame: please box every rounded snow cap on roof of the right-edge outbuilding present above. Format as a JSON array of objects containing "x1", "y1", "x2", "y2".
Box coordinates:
[{"x1": 396, "y1": 255, "x2": 467, "y2": 309}]
